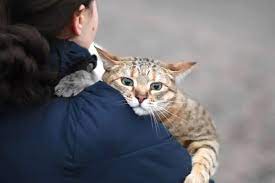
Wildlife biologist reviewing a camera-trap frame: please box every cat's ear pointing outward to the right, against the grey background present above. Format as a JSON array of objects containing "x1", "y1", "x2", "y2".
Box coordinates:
[{"x1": 164, "y1": 62, "x2": 197, "y2": 82}]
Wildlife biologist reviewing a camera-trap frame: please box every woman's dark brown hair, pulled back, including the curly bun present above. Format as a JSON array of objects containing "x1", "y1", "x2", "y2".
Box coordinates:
[{"x1": 0, "y1": 0, "x2": 92, "y2": 105}]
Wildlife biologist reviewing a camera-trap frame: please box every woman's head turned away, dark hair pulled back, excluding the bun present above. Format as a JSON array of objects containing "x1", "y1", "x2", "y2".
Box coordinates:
[{"x1": 8, "y1": 0, "x2": 98, "y2": 48}]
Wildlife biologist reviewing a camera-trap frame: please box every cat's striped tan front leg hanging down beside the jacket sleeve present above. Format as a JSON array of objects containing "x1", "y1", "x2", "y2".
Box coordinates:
[{"x1": 184, "y1": 140, "x2": 219, "y2": 183}]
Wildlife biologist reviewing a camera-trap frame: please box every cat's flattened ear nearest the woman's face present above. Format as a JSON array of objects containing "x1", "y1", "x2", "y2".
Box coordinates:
[{"x1": 95, "y1": 46, "x2": 121, "y2": 70}]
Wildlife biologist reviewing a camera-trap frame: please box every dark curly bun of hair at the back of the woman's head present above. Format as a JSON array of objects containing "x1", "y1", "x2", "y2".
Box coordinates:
[{"x1": 0, "y1": 25, "x2": 55, "y2": 104}]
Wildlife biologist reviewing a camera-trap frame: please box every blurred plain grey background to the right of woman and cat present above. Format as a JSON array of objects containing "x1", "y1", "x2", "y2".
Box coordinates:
[{"x1": 97, "y1": 0, "x2": 275, "y2": 183}]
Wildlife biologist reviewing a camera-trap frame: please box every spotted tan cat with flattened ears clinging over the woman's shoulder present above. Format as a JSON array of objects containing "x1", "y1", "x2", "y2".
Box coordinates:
[{"x1": 55, "y1": 48, "x2": 219, "y2": 183}]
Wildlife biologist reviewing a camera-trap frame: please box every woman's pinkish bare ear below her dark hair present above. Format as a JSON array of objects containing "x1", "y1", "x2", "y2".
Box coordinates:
[{"x1": 71, "y1": 4, "x2": 86, "y2": 36}]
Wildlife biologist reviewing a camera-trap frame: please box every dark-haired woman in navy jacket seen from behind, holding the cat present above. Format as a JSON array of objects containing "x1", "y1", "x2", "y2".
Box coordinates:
[{"x1": 0, "y1": 0, "x2": 194, "y2": 183}]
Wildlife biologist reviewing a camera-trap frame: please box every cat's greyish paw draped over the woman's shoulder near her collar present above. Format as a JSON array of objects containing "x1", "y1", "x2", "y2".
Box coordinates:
[{"x1": 55, "y1": 70, "x2": 98, "y2": 97}]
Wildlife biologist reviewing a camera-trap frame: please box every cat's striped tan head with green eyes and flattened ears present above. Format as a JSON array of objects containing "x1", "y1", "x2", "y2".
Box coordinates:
[{"x1": 97, "y1": 48, "x2": 195, "y2": 115}]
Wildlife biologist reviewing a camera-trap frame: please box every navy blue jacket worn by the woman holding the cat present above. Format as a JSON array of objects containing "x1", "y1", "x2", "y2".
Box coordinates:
[{"x1": 0, "y1": 40, "x2": 194, "y2": 183}]
